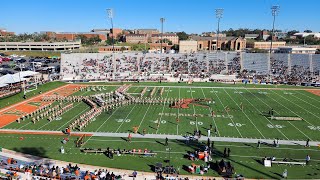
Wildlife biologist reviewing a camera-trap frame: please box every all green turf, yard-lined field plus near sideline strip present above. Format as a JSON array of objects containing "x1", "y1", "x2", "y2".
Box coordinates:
[{"x1": 0, "y1": 83, "x2": 320, "y2": 179}]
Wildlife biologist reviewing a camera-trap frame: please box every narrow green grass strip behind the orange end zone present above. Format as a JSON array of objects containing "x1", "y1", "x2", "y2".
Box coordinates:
[{"x1": 0, "y1": 81, "x2": 66, "y2": 109}]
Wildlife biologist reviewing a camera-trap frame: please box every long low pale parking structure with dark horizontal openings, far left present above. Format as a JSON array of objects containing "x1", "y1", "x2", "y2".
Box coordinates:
[{"x1": 0, "y1": 41, "x2": 81, "y2": 51}]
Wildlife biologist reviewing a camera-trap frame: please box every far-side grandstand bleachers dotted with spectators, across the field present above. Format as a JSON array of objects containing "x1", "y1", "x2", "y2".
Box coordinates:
[{"x1": 61, "y1": 52, "x2": 320, "y2": 80}]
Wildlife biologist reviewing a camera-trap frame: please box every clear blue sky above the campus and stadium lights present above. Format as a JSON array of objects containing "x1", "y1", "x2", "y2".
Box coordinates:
[{"x1": 0, "y1": 0, "x2": 320, "y2": 33}]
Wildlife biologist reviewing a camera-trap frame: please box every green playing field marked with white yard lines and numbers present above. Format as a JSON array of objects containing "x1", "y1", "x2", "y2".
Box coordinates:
[{"x1": 5, "y1": 86, "x2": 320, "y2": 140}]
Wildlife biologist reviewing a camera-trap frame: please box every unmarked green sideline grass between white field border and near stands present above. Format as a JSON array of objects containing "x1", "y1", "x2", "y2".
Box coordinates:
[{"x1": 0, "y1": 134, "x2": 320, "y2": 179}]
